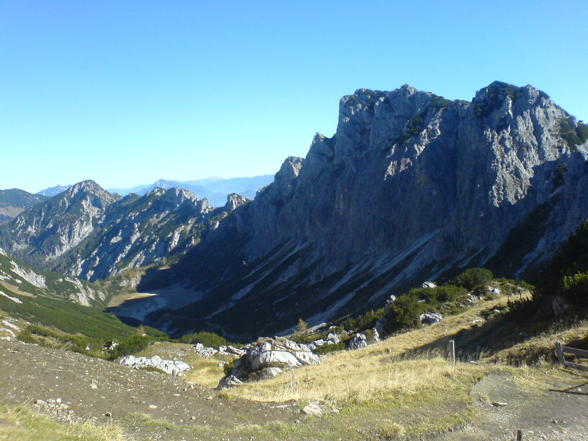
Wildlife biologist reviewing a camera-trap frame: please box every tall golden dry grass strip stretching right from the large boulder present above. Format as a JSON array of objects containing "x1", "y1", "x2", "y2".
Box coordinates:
[{"x1": 226, "y1": 298, "x2": 524, "y2": 402}]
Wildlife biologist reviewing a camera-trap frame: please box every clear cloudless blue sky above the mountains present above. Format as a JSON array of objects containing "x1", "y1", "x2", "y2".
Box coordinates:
[{"x1": 0, "y1": 0, "x2": 588, "y2": 191}]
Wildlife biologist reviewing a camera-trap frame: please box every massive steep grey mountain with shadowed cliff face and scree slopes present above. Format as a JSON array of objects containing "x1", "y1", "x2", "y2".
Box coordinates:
[{"x1": 136, "y1": 82, "x2": 588, "y2": 336}]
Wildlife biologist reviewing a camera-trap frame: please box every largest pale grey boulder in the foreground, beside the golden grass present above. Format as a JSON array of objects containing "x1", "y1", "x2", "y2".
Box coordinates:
[{"x1": 219, "y1": 338, "x2": 320, "y2": 388}]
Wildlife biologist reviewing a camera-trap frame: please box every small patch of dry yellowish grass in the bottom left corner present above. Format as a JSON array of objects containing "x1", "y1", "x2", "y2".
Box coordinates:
[{"x1": 0, "y1": 406, "x2": 124, "y2": 441}]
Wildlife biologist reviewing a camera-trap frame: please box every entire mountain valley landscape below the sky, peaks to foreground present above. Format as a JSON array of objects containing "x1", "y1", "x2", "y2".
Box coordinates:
[{"x1": 0, "y1": 81, "x2": 588, "y2": 441}]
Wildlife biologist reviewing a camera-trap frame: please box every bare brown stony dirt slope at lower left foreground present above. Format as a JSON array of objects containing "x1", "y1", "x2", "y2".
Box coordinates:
[{"x1": 0, "y1": 341, "x2": 300, "y2": 440}]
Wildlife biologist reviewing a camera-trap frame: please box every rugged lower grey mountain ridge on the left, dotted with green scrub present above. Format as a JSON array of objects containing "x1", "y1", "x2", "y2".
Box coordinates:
[{"x1": 0, "y1": 181, "x2": 245, "y2": 280}]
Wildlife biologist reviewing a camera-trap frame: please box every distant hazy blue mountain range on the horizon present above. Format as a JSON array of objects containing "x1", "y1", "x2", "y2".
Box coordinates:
[{"x1": 110, "y1": 175, "x2": 273, "y2": 207}]
